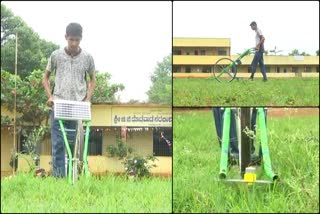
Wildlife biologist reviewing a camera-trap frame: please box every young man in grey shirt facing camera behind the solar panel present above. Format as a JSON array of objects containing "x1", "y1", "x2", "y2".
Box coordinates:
[{"x1": 43, "y1": 23, "x2": 95, "y2": 177}]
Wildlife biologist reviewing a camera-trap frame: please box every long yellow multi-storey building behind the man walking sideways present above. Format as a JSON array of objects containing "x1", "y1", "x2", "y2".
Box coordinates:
[{"x1": 173, "y1": 38, "x2": 319, "y2": 77}]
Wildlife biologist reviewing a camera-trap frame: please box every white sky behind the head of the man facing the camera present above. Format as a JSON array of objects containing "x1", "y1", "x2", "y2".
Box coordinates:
[{"x1": 1, "y1": 1, "x2": 172, "y2": 102}]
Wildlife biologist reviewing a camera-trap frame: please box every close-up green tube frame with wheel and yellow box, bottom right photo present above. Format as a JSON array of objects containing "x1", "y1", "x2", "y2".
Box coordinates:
[{"x1": 219, "y1": 107, "x2": 278, "y2": 184}]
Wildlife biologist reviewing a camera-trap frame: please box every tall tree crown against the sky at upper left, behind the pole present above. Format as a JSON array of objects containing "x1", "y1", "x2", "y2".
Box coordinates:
[{"x1": 1, "y1": 4, "x2": 59, "y2": 78}]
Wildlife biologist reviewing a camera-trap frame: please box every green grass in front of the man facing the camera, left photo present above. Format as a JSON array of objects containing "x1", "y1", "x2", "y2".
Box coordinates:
[{"x1": 1, "y1": 174, "x2": 172, "y2": 213}]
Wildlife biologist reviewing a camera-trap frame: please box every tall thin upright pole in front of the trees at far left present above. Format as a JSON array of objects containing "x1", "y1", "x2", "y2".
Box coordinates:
[{"x1": 12, "y1": 33, "x2": 18, "y2": 175}]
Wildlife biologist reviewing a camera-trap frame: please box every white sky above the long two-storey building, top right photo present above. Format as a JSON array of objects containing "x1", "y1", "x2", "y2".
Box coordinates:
[{"x1": 173, "y1": 1, "x2": 319, "y2": 55}]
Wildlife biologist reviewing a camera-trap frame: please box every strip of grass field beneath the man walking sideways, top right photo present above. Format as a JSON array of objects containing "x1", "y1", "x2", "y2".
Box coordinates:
[{"x1": 173, "y1": 78, "x2": 319, "y2": 107}]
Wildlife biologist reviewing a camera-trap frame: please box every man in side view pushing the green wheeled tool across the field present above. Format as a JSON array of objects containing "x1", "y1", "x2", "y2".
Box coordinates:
[{"x1": 250, "y1": 21, "x2": 267, "y2": 81}]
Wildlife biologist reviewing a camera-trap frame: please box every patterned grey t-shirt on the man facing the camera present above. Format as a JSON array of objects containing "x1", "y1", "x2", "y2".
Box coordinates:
[{"x1": 46, "y1": 49, "x2": 95, "y2": 101}]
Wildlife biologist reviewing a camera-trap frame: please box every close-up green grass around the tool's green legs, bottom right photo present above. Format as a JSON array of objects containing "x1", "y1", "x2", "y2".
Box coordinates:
[{"x1": 173, "y1": 111, "x2": 319, "y2": 213}]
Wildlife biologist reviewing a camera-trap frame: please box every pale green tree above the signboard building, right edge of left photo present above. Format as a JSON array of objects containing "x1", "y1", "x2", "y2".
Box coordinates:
[{"x1": 147, "y1": 55, "x2": 172, "y2": 104}]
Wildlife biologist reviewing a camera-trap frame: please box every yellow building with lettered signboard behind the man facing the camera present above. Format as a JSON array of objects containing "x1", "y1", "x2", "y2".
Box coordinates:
[{"x1": 1, "y1": 104, "x2": 172, "y2": 176}]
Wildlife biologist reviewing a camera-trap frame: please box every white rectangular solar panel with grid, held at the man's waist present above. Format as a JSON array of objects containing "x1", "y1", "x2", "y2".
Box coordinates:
[{"x1": 53, "y1": 100, "x2": 91, "y2": 121}]
